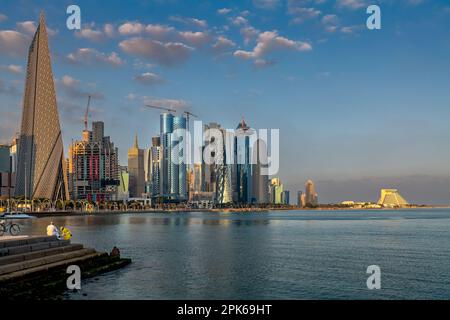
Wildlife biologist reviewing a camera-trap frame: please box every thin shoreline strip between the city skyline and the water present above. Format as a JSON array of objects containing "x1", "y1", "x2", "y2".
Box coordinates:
[{"x1": 16, "y1": 205, "x2": 450, "y2": 218}]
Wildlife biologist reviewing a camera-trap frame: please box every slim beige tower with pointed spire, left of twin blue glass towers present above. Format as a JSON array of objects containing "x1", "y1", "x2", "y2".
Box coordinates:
[{"x1": 128, "y1": 135, "x2": 145, "y2": 198}]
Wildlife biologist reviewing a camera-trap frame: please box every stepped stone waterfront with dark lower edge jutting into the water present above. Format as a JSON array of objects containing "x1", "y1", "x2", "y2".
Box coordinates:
[{"x1": 0, "y1": 236, "x2": 131, "y2": 299}]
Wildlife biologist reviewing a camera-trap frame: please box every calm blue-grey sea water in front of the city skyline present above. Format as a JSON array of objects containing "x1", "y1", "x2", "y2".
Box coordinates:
[{"x1": 15, "y1": 209, "x2": 450, "y2": 299}]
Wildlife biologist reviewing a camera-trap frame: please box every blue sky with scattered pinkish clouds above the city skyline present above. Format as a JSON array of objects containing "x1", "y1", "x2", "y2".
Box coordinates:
[{"x1": 0, "y1": 0, "x2": 450, "y2": 203}]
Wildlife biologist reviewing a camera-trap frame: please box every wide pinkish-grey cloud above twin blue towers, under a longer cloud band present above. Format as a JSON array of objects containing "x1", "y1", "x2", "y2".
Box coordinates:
[{"x1": 119, "y1": 38, "x2": 193, "y2": 66}]
